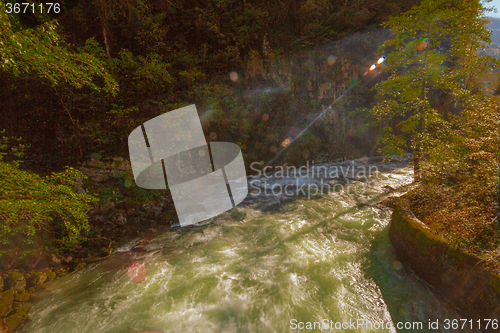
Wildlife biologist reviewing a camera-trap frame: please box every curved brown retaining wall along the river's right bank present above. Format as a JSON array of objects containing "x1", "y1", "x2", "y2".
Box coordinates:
[{"x1": 389, "y1": 198, "x2": 500, "y2": 332}]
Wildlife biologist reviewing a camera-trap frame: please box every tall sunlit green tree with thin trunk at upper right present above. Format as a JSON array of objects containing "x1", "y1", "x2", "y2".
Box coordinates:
[{"x1": 372, "y1": 0, "x2": 499, "y2": 179}]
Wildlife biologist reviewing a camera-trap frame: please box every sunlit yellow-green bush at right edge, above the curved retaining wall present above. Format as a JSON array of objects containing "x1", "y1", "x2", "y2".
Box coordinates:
[{"x1": 425, "y1": 96, "x2": 500, "y2": 191}]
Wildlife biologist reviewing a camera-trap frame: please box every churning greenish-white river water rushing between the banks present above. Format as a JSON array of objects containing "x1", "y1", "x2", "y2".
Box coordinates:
[{"x1": 21, "y1": 161, "x2": 480, "y2": 333}]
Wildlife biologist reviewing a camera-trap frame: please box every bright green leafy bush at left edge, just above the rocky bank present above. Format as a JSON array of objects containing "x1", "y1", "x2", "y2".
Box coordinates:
[{"x1": 0, "y1": 155, "x2": 93, "y2": 251}]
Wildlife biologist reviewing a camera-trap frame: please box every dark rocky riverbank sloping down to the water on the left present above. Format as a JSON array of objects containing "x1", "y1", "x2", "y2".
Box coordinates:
[{"x1": 0, "y1": 158, "x2": 176, "y2": 333}]
